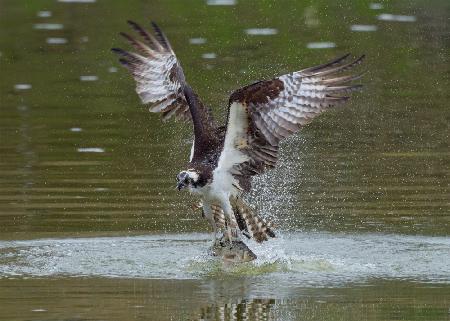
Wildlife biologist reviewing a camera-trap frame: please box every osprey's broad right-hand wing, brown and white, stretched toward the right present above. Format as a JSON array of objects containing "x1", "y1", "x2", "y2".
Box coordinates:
[{"x1": 218, "y1": 54, "x2": 364, "y2": 181}]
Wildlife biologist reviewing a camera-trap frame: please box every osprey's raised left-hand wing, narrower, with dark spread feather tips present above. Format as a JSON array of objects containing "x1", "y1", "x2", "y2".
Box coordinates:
[{"x1": 111, "y1": 21, "x2": 218, "y2": 159}]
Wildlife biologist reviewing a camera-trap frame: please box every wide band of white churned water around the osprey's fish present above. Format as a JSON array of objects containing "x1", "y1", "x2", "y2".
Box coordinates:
[{"x1": 0, "y1": 232, "x2": 450, "y2": 286}]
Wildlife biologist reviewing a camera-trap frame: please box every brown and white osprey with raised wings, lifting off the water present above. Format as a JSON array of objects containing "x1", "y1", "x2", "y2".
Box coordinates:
[{"x1": 112, "y1": 21, "x2": 364, "y2": 260}]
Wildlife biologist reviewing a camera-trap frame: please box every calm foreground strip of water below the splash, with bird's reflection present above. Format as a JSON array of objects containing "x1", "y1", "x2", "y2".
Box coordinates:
[{"x1": 0, "y1": 278, "x2": 449, "y2": 321}]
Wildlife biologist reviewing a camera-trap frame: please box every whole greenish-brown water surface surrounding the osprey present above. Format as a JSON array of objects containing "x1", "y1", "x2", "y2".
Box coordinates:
[{"x1": 0, "y1": 0, "x2": 450, "y2": 321}]
